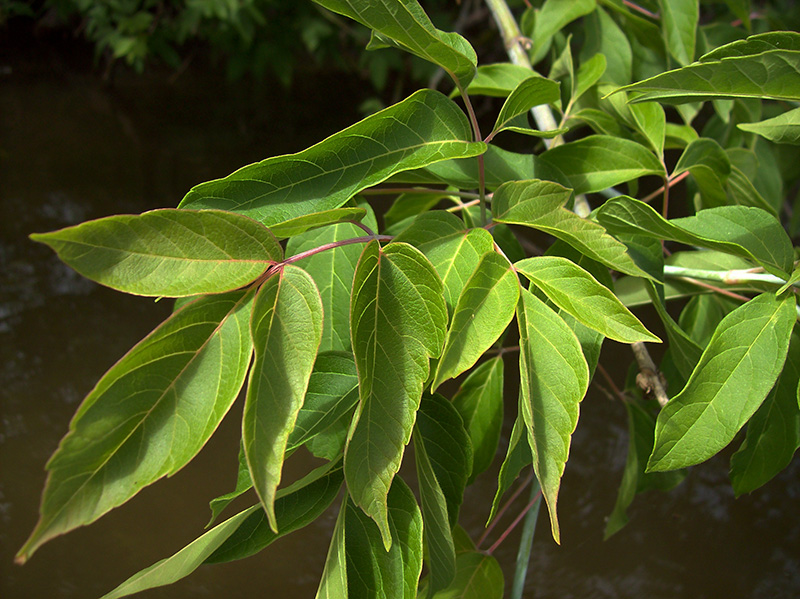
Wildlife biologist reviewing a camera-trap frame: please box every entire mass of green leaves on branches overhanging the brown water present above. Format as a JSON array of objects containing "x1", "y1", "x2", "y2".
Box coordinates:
[{"x1": 18, "y1": 0, "x2": 800, "y2": 599}]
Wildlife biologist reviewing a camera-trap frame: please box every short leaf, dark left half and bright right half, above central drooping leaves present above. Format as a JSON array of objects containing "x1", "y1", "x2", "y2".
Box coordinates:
[{"x1": 395, "y1": 210, "x2": 494, "y2": 314}]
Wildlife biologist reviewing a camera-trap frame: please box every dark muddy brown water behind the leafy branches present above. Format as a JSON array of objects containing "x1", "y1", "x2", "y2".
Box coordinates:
[{"x1": 0, "y1": 38, "x2": 800, "y2": 599}]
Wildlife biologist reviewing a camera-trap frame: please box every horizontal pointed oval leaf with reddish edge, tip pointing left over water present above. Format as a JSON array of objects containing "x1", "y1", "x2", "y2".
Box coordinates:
[{"x1": 31, "y1": 209, "x2": 283, "y2": 297}]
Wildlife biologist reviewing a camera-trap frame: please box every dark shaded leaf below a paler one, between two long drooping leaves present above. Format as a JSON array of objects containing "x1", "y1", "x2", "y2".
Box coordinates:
[{"x1": 286, "y1": 353, "x2": 358, "y2": 459}]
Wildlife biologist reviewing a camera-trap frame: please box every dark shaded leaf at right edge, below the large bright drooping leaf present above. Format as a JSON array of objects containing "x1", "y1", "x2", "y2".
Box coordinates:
[{"x1": 731, "y1": 335, "x2": 800, "y2": 497}]
